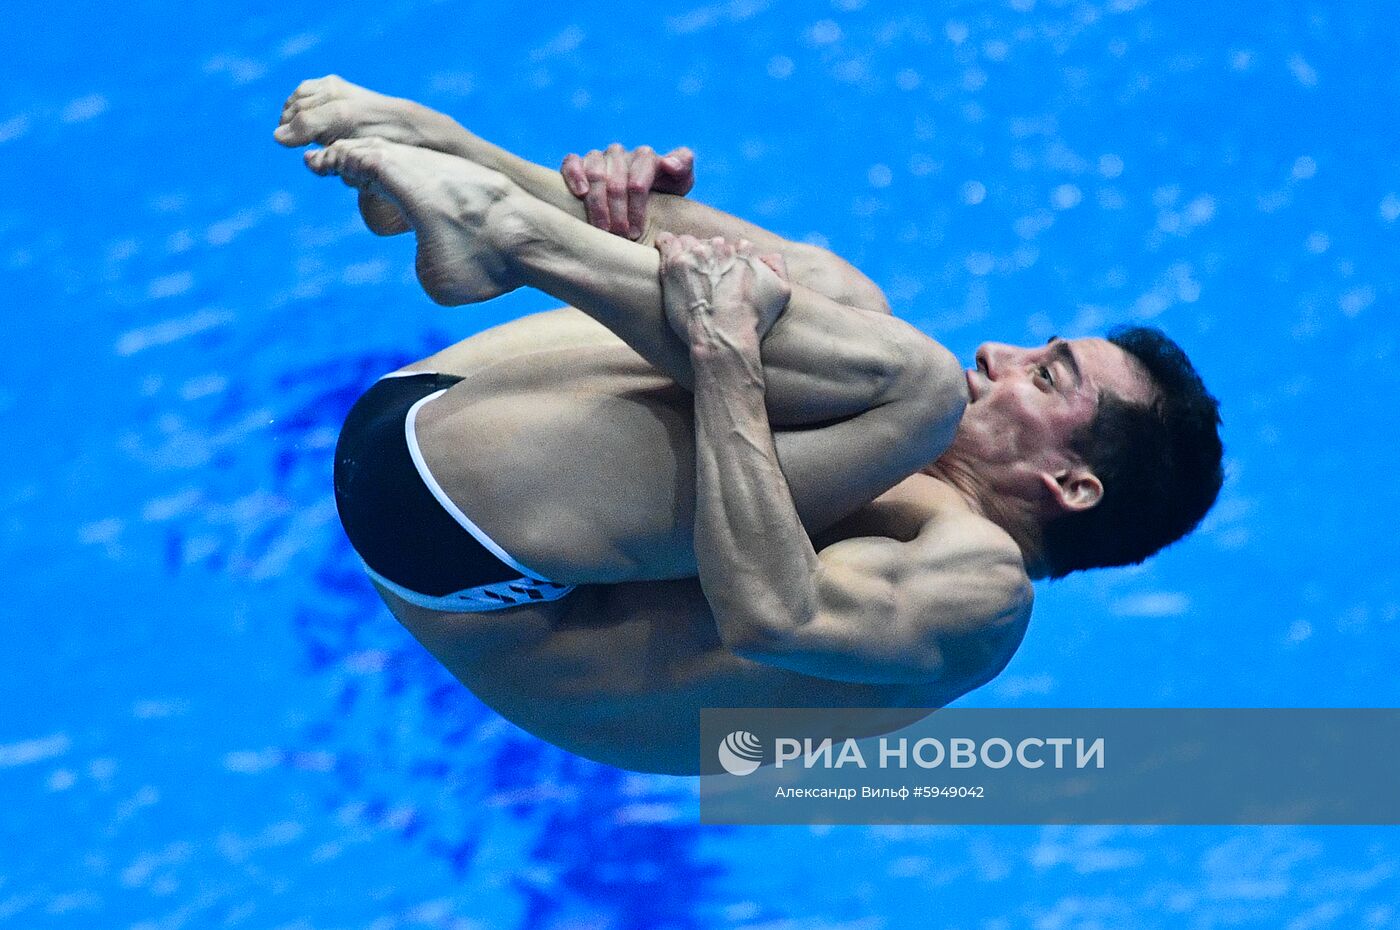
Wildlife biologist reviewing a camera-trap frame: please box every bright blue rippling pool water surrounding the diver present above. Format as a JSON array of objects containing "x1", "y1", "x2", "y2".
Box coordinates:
[{"x1": 0, "y1": 0, "x2": 1400, "y2": 930}]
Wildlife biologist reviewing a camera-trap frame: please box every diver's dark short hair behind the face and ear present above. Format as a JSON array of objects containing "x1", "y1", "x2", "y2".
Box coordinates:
[{"x1": 1042, "y1": 326, "x2": 1225, "y2": 578}]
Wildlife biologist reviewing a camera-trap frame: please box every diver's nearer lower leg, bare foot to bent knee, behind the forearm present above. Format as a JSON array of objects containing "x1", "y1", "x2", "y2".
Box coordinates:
[{"x1": 307, "y1": 139, "x2": 966, "y2": 428}]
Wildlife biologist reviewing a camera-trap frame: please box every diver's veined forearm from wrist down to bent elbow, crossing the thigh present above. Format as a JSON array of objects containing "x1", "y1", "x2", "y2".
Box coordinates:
[{"x1": 692, "y1": 324, "x2": 819, "y2": 654}]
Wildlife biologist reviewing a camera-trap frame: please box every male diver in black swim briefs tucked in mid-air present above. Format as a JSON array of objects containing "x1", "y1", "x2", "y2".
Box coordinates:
[{"x1": 276, "y1": 77, "x2": 1221, "y2": 773}]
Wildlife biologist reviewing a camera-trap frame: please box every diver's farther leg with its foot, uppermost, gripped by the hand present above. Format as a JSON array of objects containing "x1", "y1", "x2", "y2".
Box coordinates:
[{"x1": 274, "y1": 76, "x2": 889, "y2": 314}]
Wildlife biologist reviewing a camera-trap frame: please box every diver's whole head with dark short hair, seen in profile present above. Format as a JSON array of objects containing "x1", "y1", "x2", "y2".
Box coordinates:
[{"x1": 949, "y1": 326, "x2": 1222, "y2": 577}]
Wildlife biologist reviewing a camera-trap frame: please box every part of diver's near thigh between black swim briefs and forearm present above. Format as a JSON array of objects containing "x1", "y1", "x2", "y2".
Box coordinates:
[{"x1": 414, "y1": 343, "x2": 694, "y2": 584}]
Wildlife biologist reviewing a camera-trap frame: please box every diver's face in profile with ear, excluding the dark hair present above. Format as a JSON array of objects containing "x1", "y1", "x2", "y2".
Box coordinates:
[{"x1": 949, "y1": 338, "x2": 1151, "y2": 508}]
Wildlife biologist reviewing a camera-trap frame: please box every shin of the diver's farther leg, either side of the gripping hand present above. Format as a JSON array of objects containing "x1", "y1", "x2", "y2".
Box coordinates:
[{"x1": 421, "y1": 111, "x2": 889, "y2": 314}]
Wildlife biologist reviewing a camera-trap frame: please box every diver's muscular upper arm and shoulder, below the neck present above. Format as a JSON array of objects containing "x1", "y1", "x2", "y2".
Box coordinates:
[{"x1": 736, "y1": 521, "x2": 1033, "y2": 683}]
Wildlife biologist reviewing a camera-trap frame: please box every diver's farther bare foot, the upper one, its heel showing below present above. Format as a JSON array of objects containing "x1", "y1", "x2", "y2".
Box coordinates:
[{"x1": 273, "y1": 74, "x2": 452, "y2": 235}]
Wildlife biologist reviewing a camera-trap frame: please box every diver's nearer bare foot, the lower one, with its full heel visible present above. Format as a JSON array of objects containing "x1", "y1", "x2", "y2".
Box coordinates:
[{"x1": 305, "y1": 139, "x2": 522, "y2": 307}]
